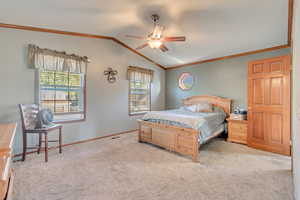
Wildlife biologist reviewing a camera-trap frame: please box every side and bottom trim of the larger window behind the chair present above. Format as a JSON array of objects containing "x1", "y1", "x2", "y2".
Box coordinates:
[{"x1": 36, "y1": 69, "x2": 87, "y2": 124}]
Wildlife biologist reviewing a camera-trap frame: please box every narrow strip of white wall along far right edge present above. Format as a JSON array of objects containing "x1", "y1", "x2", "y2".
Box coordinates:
[{"x1": 292, "y1": 0, "x2": 300, "y2": 200}]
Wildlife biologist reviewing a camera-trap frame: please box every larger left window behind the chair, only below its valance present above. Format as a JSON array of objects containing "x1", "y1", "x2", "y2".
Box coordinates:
[{"x1": 39, "y1": 70, "x2": 85, "y2": 121}]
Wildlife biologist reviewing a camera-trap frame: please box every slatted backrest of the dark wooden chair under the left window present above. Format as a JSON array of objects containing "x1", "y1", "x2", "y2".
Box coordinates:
[{"x1": 19, "y1": 104, "x2": 39, "y2": 131}]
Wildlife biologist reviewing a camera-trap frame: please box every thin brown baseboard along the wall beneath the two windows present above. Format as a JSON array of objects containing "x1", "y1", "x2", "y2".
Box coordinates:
[{"x1": 13, "y1": 129, "x2": 138, "y2": 158}]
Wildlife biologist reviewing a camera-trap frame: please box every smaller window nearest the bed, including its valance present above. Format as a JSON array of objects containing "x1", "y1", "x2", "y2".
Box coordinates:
[{"x1": 128, "y1": 67, "x2": 153, "y2": 115}]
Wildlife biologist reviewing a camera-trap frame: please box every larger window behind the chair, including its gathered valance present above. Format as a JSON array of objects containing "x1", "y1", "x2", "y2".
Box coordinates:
[{"x1": 28, "y1": 44, "x2": 89, "y2": 122}]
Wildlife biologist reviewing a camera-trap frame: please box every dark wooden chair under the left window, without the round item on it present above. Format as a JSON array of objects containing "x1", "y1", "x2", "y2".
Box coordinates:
[{"x1": 19, "y1": 104, "x2": 62, "y2": 162}]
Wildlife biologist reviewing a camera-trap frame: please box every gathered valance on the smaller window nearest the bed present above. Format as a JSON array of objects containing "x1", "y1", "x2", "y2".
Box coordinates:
[{"x1": 127, "y1": 66, "x2": 154, "y2": 82}]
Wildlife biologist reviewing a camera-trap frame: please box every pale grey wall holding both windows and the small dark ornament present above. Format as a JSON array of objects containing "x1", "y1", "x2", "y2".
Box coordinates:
[{"x1": 0, "y1": 28, "x2": 165, "y2": 153}]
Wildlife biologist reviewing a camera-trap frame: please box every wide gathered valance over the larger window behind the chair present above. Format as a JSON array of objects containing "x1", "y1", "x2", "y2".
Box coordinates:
[{"x1": 28, "y1": 44, "x2": 89, "y2": 73}]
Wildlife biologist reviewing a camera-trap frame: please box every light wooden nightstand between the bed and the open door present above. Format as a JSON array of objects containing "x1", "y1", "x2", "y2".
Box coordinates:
[{"x1": 227, "y1": 119, "x2": 248, "y2": 144}]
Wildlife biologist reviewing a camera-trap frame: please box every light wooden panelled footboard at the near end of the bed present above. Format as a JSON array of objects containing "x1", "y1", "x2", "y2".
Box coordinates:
[{"x1": 138, "y1": 120, "x2": 199, "y2": 162}]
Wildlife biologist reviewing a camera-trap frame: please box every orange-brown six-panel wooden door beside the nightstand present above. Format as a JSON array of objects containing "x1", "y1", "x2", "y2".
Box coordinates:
[{"x1": 247, "y1": 56, "x2": 291, "y2": 155}]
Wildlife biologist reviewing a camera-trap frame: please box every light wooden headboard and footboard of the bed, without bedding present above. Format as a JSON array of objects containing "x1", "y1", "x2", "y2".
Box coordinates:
[{"x1": 138, "y1": 96, "x2": 231, "y2": 162}]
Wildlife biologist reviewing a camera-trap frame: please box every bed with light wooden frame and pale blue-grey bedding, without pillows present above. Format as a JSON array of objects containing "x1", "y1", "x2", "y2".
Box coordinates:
[{"x1": 138, "y1": 96, "x2": 231, "y2": 162}]
